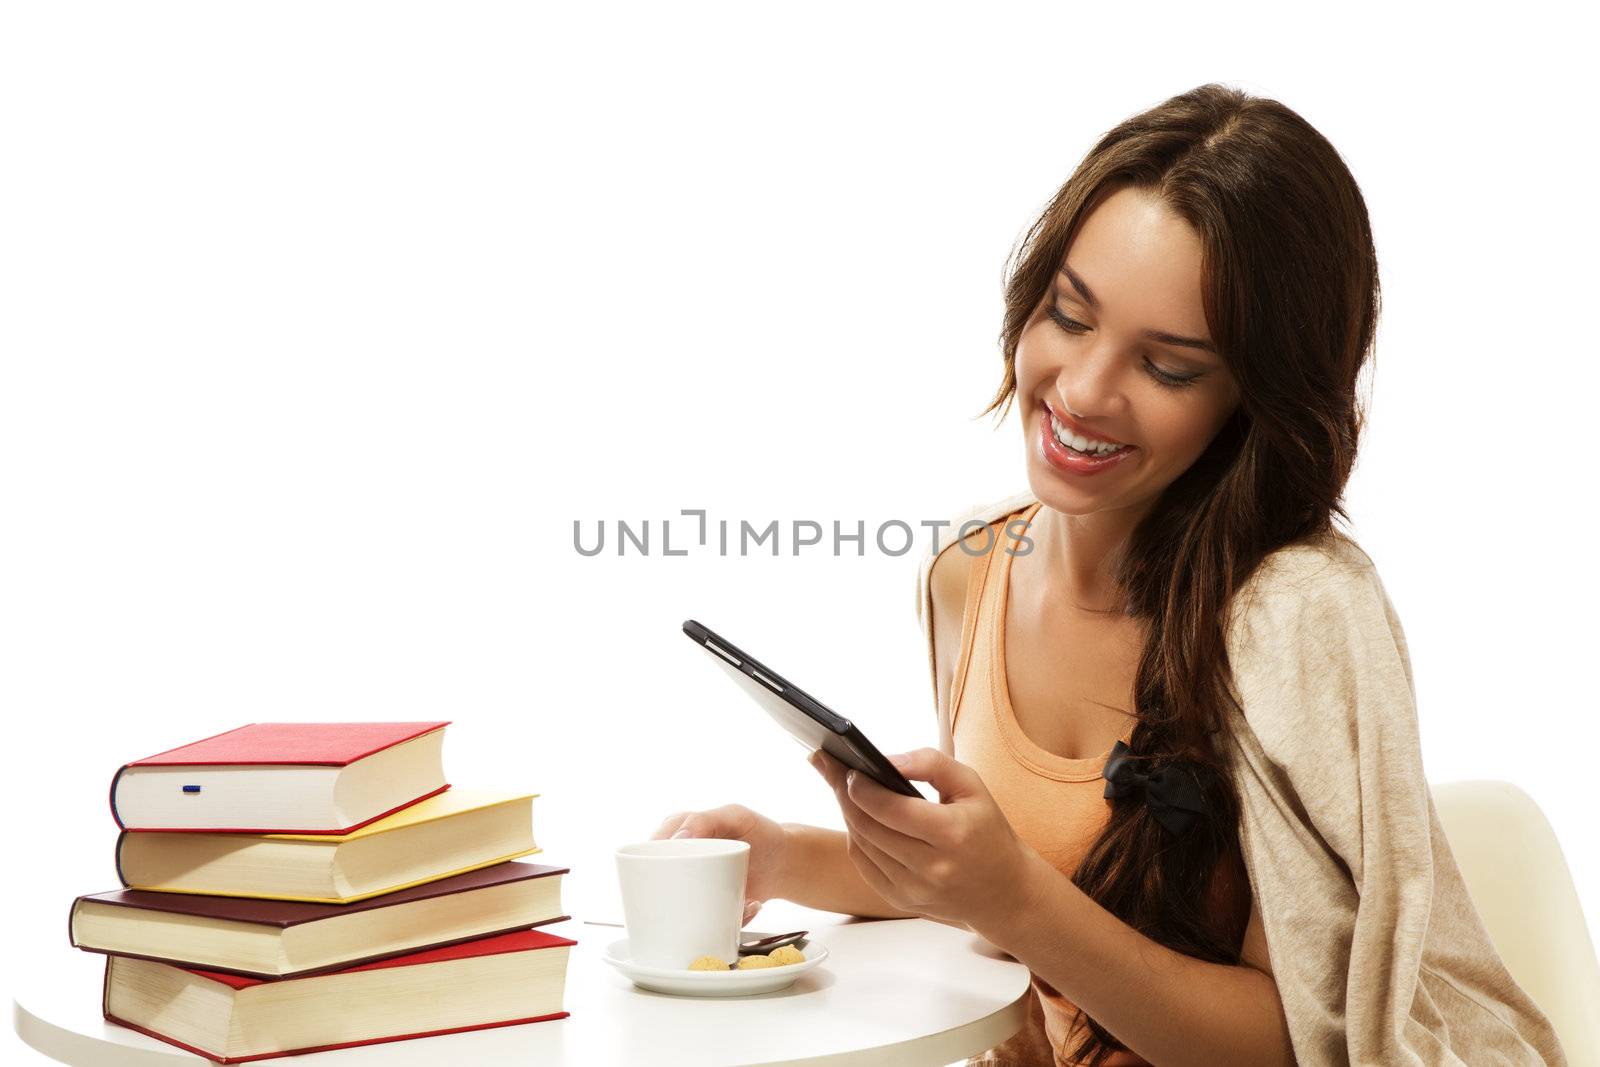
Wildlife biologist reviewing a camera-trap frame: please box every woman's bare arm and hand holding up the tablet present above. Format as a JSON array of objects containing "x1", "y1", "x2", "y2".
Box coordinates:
[{"x1": 813, "y1": 749, "x2": 1299, "y2": 1067}]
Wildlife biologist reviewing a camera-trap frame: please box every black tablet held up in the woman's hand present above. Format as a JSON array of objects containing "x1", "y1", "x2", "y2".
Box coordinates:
[{"x1": 683, "y1": 619, "x2": 926, "y2": 800}]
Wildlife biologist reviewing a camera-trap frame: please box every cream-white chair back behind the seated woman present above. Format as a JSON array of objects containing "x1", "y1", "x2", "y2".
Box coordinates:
[{"x1": 1430, "y1": 781, "x2": 1600, "y2": 1067}]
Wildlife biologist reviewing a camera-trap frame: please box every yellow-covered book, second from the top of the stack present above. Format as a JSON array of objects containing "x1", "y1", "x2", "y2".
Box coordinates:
[{"x1": 117, "y1": 789, "x2": 539, "y2": 904}]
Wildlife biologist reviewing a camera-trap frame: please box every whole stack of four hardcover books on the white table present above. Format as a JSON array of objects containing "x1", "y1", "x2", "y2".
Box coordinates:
[{"x1": 70, "y1": 723, "x2": 578, "y2": 1064}]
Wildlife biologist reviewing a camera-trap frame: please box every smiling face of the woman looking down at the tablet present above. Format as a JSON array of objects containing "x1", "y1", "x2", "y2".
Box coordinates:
[{"x1": 1016, "y1": 187, "x2": 1238, "y2": 515}]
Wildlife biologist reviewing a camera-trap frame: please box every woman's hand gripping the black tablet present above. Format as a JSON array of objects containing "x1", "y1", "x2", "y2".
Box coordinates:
[{"x1": 811, "y1": 749, "x2": 1043, "y2": 931}]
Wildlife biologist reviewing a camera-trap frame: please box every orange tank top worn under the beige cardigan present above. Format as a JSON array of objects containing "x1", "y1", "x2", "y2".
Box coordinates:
[{"x1": 950, "y1": 502, "x2": 1248, "y2": 1067}]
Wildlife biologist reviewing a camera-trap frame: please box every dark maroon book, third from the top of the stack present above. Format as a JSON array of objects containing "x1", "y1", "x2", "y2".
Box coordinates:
[{"x1": 67, "y1": 862, "x2": 571, "y2": 979}]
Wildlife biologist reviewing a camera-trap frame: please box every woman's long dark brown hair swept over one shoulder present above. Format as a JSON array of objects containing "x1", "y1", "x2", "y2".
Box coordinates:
[{"x1": 982, "y1": 83, "x2": 1379, "y2": 1064}]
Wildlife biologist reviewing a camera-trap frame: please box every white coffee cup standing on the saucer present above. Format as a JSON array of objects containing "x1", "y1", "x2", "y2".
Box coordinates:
[{"x1": 616, "y1": 837, "x2": 750, "y2": 969}]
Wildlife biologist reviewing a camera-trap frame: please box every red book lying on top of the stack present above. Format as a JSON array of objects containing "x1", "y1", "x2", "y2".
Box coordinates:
[{"x1": 110, "y1": 721, "x2": 448, "y2": 833}]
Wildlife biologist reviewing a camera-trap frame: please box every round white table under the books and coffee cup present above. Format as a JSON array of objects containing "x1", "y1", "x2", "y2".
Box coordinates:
[{"x1": 11, "y1": 901, "x2": 1029, "y2": 1067}]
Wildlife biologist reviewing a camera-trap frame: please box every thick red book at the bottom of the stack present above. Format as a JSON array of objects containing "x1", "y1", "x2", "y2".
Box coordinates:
[{"x1": 104, "y1": 929, "x2": 578, "y2": 1064}]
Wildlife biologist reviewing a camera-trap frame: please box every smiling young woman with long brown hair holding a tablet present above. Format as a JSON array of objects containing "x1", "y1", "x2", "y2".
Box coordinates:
[{"x1": 656, "y1": 85, "x2": 1565, "y2": 1067}]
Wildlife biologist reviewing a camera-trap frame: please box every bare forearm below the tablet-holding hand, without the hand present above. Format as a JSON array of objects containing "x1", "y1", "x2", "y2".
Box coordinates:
[{"x1": 973, "y1": 856, "x2": 1294, "y2": 1067}]
